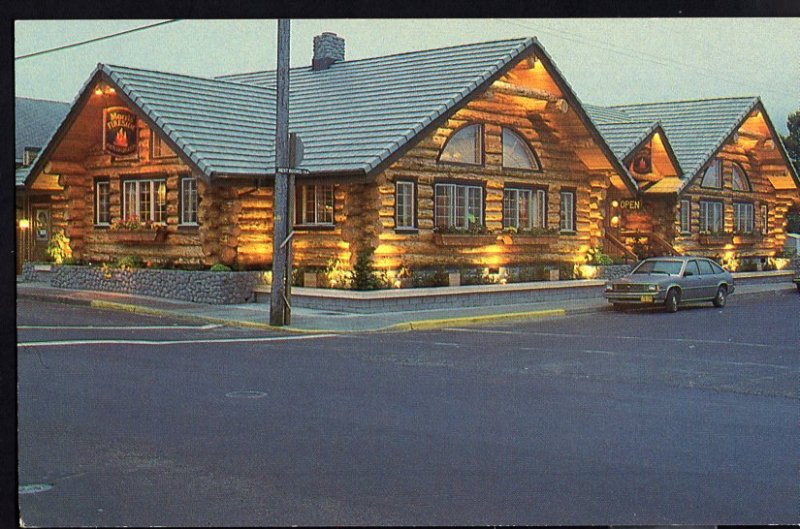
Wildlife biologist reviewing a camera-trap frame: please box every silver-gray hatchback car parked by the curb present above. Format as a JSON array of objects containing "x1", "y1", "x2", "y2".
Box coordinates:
[{"x1": 605, "y1": 256, "x2": 735, "y2": 312}]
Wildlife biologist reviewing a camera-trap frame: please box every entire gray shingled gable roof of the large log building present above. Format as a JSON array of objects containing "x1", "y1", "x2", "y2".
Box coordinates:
[{"x1": 31, "y1": 38, "x2": 636, "y2": 190}]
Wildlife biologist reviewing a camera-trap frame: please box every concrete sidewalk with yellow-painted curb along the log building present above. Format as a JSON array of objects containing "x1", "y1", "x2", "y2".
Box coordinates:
[{"x1": 17, "y1": 282, "x2": 796, "y2": 332}]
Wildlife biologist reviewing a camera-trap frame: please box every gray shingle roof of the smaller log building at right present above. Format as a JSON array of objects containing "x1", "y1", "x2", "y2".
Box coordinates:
[{"x1": 587, "y1": 97, "x2": 759, "y2": 184}]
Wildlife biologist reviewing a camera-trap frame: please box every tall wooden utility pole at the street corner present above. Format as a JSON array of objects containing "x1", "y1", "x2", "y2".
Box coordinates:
[{"x1": 269, "y1": 18, "x2": 294, "y2": 325}]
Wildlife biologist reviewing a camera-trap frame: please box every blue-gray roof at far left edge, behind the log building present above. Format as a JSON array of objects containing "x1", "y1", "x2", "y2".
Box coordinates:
[{"x1": 14, "y1": 97, "x2": 70, "y2": 163}]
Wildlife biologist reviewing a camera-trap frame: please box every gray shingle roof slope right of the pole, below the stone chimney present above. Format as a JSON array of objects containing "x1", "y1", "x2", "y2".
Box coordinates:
[{"x1": 218, "y1": 39, "x2": 534, "y2": 177}]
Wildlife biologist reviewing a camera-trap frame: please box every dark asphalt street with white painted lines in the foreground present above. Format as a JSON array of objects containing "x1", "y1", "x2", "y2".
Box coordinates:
[{"x1": 17, "y1": 293, "x2": 800, "y2": 526}]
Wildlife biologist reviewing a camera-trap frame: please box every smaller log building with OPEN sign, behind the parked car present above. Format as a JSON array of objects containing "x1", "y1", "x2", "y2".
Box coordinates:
[{"x1": 586, "y1": 97, "x2": 800, "y2": 268}]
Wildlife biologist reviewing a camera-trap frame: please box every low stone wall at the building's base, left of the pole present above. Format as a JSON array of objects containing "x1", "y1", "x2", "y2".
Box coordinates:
[{"x1": 50, "y1": 266, "x2": 260, "y2": 305}]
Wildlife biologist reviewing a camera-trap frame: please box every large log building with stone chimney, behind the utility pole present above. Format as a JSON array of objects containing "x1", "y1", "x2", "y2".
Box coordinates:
[{"x1": 21, "y1": 33, "x2": 797, "y2": 278}]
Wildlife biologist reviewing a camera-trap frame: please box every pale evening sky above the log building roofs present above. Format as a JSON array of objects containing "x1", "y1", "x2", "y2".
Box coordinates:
[{"x1": 14, "y1": 18, "x2": 800, "y2": 134}]
